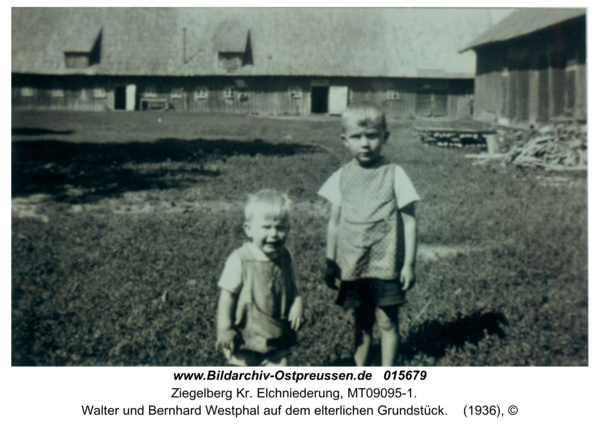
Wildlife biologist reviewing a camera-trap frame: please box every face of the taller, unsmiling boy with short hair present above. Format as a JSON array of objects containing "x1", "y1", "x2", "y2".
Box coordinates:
[{"x1": 342, "y1": 122, "x2": 389, "y2": 166}]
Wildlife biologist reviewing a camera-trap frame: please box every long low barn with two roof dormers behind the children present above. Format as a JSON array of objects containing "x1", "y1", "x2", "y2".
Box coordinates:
[{"x1": 12, "y1": 8, "x2": 502, "y2": 118}]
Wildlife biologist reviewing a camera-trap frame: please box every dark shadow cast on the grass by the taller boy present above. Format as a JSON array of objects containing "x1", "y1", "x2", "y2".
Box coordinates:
[{"x1": 324, "y1": 312, "x2": 508, "y2": 367}]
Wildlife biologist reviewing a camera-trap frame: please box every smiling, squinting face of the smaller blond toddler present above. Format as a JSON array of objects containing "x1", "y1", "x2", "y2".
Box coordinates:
[{"x1": 244, "y1": 205, "x2": 290, "y2": 259}]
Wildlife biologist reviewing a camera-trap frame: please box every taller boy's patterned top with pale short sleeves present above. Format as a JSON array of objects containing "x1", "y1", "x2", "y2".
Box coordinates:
[{"x1": 319, "y1": 159, "x2": 419, "y2": 281}]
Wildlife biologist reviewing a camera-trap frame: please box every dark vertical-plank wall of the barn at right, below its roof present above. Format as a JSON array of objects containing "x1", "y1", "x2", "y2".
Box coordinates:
[{"x1": 474, "y1": 17, "x2": 587, "y2": 124}]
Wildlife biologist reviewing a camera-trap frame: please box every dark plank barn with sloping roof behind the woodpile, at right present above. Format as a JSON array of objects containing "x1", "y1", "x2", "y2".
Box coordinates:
[{"x1": 465, "y1": 9, "x2": 587, "y2": 125}]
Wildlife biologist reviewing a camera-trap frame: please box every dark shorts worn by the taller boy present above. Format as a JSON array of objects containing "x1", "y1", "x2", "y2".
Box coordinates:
[{"x1": 335, "y1": 278, "x2": 406, "y2": 309}]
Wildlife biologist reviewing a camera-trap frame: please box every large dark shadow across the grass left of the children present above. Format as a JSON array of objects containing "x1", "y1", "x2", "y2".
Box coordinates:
[{"x1": 12, "y1": 137, "x2": 315, "y2": 202}]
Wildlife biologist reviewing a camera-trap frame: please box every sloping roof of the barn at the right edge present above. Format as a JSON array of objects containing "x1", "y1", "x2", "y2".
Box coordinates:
[{"x1": 461, "y1": 9, "x2": 586, "y2": 52}]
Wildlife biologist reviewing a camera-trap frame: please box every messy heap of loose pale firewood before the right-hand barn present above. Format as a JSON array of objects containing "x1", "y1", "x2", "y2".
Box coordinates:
[{"x1": 467, "y1": 122, "x2": 588, "y2": 171}]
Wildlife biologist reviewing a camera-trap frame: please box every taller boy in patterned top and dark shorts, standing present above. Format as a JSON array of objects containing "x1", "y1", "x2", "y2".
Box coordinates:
[{"x1": 319, "y1": 102, "x2": 419, "y2": 366}]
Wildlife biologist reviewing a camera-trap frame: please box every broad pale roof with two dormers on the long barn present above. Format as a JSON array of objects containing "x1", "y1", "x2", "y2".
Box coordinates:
[{"x1": 12, "y1": 8, "x2": 502, "y2": 78}]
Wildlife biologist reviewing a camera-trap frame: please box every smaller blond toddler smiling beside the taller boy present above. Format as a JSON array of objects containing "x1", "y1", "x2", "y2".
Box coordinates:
[{"x1": 217, "y1": 189, "x2": 303, "y2": 366}]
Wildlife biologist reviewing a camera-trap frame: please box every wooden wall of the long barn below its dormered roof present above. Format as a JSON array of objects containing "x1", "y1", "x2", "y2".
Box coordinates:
[{"x1": 12, "y1": 75, "x2": 473, "y2": 119}]
